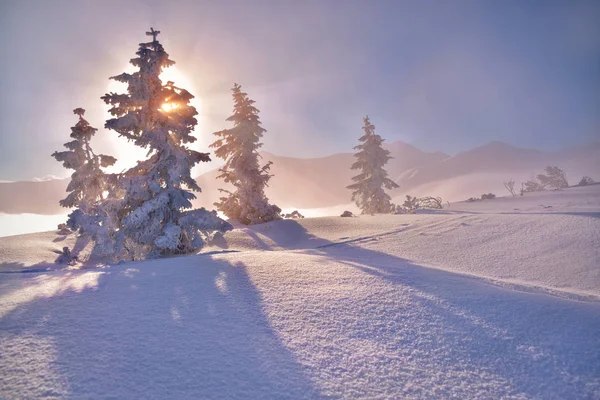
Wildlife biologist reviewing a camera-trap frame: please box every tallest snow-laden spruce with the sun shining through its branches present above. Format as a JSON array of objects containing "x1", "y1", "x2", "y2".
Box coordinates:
[{"x1": 102, "y1": 28, "x2": 232, "y2": 259}]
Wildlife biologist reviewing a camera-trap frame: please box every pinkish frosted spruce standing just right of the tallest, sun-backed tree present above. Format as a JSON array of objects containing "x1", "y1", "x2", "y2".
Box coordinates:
[{"x1": 210, "y1": 83, "x2": 281, "y2": 225}]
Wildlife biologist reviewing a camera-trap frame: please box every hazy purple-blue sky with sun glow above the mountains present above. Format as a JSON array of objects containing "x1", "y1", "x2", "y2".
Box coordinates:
[{"x1": 0, "y1": 0, "x2": 600, "y2": 180}]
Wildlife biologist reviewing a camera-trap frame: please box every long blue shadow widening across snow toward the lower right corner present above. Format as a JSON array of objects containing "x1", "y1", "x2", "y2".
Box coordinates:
[{"x1": 256, "y1": 221, "x2": 600, "y2": 398}]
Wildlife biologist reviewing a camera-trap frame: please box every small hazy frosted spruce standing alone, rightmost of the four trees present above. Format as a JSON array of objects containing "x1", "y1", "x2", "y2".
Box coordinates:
[{"x1": 347, "y1": 116, "x2": 398, "y2": 215}]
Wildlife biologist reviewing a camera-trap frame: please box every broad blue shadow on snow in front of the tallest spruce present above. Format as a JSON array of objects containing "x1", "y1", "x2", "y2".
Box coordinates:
[{"x1": 0, "y1": 256, "x2": 319, "y2": 399}]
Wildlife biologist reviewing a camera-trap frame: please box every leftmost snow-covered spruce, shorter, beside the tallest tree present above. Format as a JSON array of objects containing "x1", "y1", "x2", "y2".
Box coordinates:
[{"x1": 52, "y1": 108, "x2": 117, "y2": 256}]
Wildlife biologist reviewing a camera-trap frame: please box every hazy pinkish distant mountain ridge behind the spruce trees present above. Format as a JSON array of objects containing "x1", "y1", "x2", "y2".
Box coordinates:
[{"x1": 0, "y1": 141, "x2": 600, "y2": 214}]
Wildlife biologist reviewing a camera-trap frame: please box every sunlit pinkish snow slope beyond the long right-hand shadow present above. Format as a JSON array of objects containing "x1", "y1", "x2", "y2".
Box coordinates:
[{"x1": 209, "y1": 214, "x2": 600, "y2": 300}]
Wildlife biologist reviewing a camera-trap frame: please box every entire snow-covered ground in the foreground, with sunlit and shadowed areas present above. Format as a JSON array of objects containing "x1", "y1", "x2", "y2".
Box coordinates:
[{"x1": 0, "y1": 186, "x2": 600, "y2": 399}]
